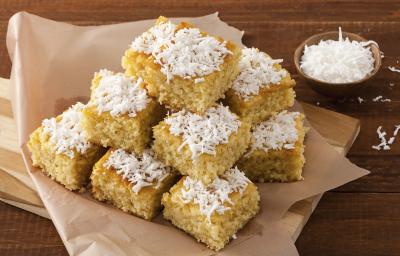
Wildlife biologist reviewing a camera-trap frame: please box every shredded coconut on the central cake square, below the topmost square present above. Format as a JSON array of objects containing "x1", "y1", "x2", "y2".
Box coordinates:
[{"x1": 165, "y1": 105, "x2": 240, "y2": 160}]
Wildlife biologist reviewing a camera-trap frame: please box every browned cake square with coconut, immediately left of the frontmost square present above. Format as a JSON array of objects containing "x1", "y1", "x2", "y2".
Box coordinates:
[{"x1": 90, "y1": 149, "x2": 177, "y2": 220}]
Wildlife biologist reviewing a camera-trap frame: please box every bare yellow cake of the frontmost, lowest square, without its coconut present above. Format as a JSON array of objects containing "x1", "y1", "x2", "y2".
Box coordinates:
[{"x1": 162, "y1": 177, "x2": 260, "y2": 251}]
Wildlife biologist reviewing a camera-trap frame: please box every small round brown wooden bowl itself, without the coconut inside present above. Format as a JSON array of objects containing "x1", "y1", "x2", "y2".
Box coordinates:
[{"x1": 293, "y1": 31, "x2": 382, "y2": 97}]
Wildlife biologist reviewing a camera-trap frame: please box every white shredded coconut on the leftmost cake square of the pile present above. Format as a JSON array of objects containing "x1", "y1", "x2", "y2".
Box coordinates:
[{"x1": 42, "y1": 102, "x2": 91, "y2": 159}]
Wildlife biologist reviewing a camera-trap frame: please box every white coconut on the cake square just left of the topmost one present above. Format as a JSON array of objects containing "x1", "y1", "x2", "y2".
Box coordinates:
[{"x1": 92, "y1": 70, "x2": 150, "y2": 117}]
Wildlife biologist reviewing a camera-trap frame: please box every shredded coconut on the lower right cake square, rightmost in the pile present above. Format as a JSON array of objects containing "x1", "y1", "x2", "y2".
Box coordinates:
[{"x1": 250, "y1": 110, "x2": 300, "y2": 152}]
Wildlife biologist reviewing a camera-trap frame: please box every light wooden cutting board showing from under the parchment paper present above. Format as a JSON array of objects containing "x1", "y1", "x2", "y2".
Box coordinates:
[{"x1": 0, "y1": 78, "x2": 360, "y2": 241}]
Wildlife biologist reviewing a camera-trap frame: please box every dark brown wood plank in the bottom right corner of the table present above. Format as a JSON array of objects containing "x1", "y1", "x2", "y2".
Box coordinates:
[{"x1": 296, "y1": 193, "x2": 400, "y2": 256}]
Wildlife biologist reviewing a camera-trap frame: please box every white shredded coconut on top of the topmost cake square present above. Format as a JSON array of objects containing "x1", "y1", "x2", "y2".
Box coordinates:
[{"x1": 132, "y1": 22, "x2": 232, "y2": 82}]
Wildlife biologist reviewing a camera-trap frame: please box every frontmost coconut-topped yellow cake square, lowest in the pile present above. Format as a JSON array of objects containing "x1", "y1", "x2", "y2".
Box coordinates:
[{"x1": 162, "y1": 168, "x2": 260, "y2": 251}]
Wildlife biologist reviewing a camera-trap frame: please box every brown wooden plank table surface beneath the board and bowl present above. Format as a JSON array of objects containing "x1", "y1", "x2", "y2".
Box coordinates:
[{"x1": 0, "y1": 0, "x2": 400, "y2": 256}]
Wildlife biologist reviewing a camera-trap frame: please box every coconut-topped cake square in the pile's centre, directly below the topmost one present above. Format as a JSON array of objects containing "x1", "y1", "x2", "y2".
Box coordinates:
[{"x1": 153, "y1": 105, "x2": 251, "y2": 184}]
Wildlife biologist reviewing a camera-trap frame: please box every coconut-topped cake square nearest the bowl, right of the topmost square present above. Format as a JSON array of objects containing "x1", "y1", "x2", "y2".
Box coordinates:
[{"x1": 226, "y1": 48, "x2": 296, "y2": 126}]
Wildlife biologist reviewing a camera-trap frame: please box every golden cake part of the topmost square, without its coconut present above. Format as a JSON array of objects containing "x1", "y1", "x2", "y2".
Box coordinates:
[{"x1": 122, "y1": 17, "x2": 241, "y2": 113}]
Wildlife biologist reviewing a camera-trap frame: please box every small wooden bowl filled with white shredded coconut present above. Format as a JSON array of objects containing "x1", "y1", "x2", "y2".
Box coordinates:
[{"x1": 294, "y1": 27, "x2": 382, "y2": 97}]
